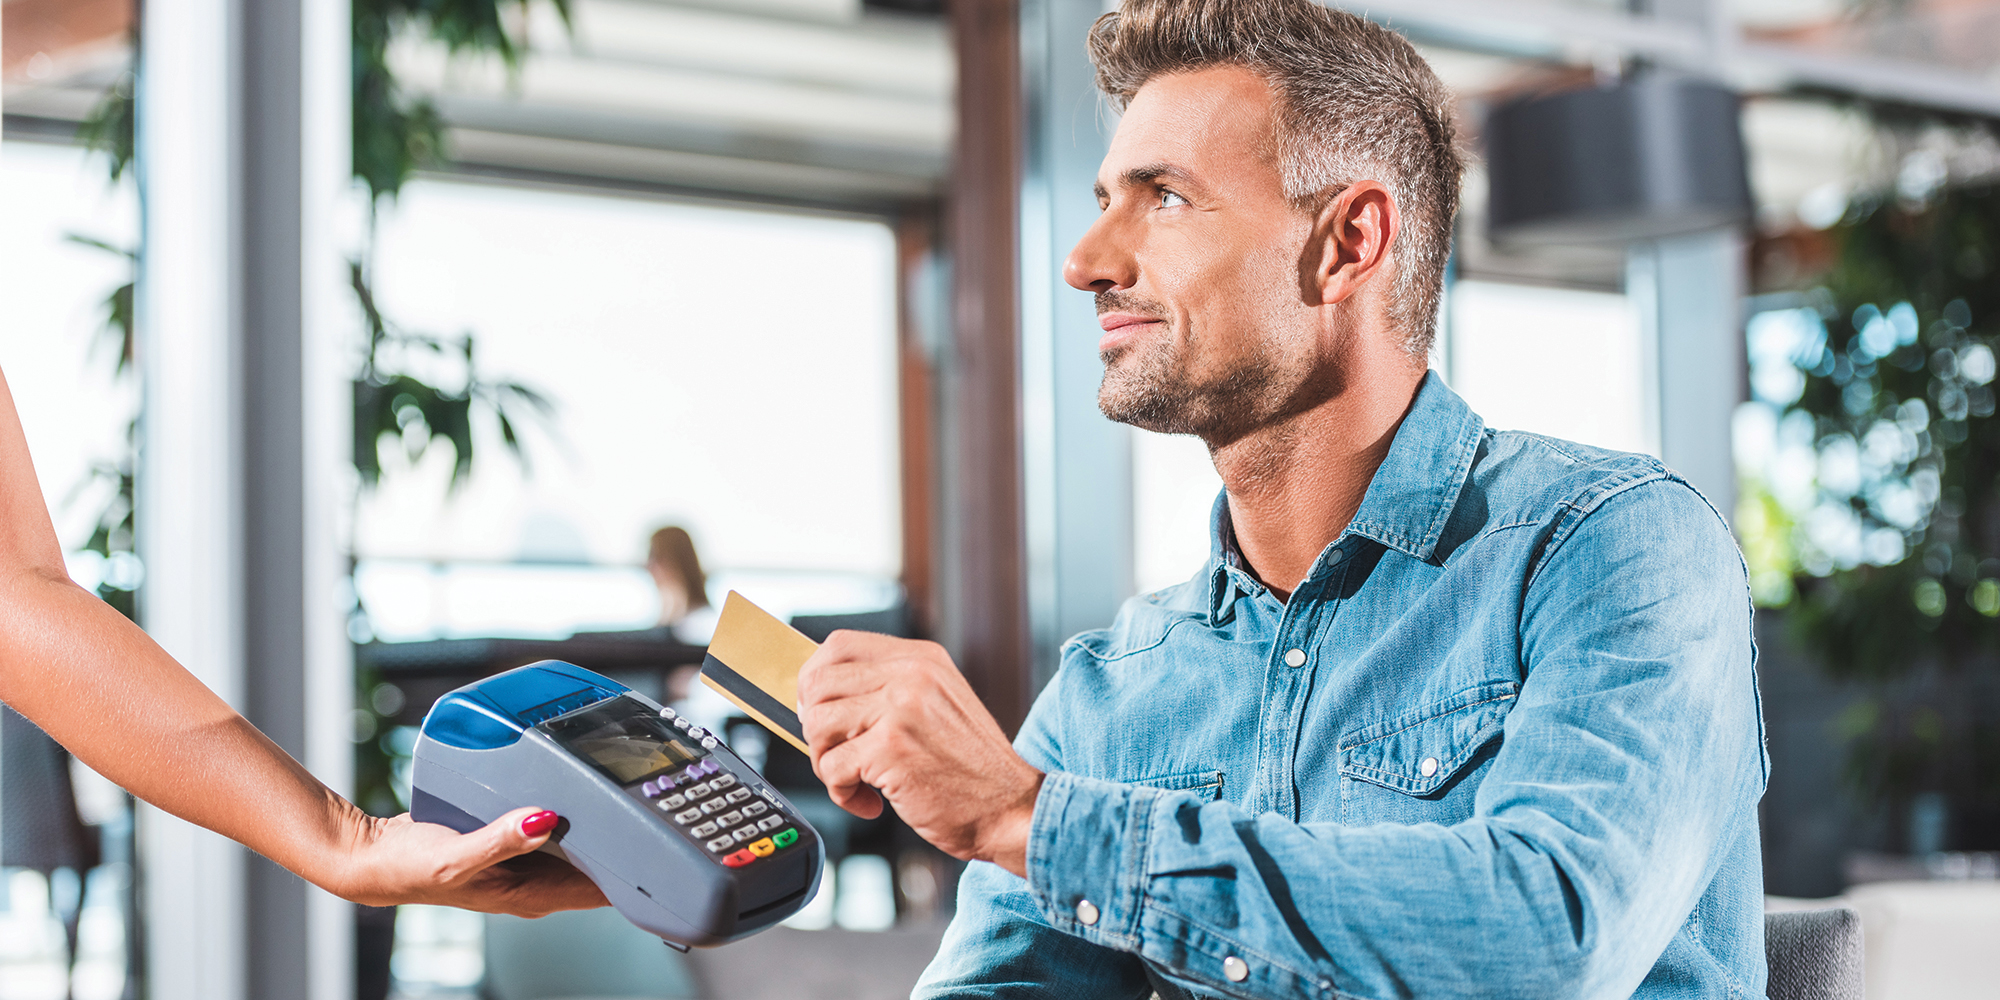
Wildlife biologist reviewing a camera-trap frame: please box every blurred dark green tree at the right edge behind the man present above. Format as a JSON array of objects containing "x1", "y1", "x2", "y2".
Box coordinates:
[{"x1": 1746, "y1": 176, "x2": 2000, "y2": 850}]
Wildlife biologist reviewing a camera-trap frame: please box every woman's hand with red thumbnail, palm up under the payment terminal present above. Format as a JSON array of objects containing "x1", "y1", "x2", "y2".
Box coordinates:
[{"x1": 338, "y1": 808, "x2": 606, "y2": 916}]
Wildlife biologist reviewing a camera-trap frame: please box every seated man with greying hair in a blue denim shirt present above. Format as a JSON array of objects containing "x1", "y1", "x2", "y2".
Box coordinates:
[{"x1": 800, "y1": 0, "x2": 1768, "y2": 998}]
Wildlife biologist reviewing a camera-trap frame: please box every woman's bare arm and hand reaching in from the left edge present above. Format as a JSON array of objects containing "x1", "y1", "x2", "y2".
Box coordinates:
[{"x1": 0, "y1": 374, "x2": 604, "y2": 916}]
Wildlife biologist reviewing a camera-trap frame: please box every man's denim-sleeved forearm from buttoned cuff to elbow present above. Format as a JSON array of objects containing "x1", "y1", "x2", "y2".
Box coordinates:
[{"x1": 1028, "y1": 774, "x2": 1682, "y2": 998}]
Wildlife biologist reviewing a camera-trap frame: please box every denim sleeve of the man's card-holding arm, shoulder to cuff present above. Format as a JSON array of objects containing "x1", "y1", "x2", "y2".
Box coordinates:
[{"x1": 968, "y1": 478, "x2": 1766, "y2": 1000}]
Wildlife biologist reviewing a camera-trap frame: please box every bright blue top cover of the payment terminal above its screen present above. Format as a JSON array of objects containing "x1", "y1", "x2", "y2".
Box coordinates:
[{"x1": 424, "y1": 660, "x2": 630, "y2": 750}]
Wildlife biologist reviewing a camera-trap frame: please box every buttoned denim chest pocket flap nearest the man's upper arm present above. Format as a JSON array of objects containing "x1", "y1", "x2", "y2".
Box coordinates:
[{"x1": 1340, "y1": 680, "x2": 1520, "y2": 796}]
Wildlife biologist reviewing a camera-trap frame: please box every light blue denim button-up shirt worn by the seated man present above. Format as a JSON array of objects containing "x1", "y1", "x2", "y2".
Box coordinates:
[{"x1": 914, "y1": 376, "x2": 1770, "y2": 1000}]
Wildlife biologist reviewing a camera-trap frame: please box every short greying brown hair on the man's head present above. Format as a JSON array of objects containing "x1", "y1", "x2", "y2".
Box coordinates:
[{"x1": 1090, "y1": 0, "x2": 1464, "y2": 358}]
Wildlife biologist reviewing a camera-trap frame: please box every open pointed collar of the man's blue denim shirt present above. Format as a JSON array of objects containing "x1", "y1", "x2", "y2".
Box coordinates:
[{"x1": 1208, "y1": 372, "x2": 1486, "y2": 622}]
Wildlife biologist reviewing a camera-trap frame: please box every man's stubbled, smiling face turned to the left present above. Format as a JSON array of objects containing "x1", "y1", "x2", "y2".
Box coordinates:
[{"x1": 1064, "y1": 66, "x2": 1340, "y2": 446}]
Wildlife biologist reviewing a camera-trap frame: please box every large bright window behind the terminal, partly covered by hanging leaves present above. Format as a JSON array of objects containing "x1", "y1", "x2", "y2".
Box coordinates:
[{"x1": 354, "y1": 180, "x2": 902, "y2": 638}]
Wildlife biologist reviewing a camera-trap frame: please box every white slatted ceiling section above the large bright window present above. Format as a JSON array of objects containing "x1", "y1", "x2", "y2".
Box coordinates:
[{"x1": 392, "y1": 0, "x2": 954, "y2": 204}]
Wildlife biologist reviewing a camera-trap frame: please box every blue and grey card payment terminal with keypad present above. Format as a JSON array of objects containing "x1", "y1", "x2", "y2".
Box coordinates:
[{"x1": 410, "y1": 660, "x2": 824, "y2": 948}]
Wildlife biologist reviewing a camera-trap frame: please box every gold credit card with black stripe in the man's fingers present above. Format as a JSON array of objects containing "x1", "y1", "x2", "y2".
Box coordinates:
[{"x1": 702, "y1": 590, "x2": 820, "y2": 754}]
